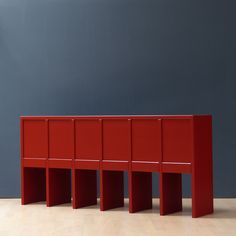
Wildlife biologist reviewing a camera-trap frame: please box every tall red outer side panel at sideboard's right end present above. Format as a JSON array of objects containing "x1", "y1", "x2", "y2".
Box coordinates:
[{"x1": 192, "y1": 116, "x2": 213, "y2": 217}]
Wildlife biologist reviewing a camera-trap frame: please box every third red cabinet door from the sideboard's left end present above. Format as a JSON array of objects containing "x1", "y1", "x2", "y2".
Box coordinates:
[{"x1": 75, "y1": 120, "x2": 101, "y2": 160}]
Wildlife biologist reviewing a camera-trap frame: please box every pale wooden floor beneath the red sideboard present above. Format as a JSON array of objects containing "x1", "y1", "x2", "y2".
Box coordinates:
[{"x1": 0, "y1": 199, "x2": 236, "y2": 236}]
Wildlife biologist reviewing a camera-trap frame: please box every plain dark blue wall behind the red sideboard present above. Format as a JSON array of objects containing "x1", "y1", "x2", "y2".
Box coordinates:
[{"x1": 0, "y1": 0, "x2": 236, "y2": 197}]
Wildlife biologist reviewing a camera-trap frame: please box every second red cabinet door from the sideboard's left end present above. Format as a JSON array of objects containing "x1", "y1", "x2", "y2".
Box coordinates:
[{"x1": 49, "y1": 120, "x2": 74, "y2": 159}]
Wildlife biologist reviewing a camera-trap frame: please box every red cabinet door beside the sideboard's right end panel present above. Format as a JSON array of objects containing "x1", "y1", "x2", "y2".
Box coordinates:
[{"x1": 162, "y1": 118, "x2": 193, "y2": 163}]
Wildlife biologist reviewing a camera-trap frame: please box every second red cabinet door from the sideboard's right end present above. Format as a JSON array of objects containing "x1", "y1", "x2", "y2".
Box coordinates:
[{"x1": 132, "y1": 119, "x2": 161, "y2": 162}]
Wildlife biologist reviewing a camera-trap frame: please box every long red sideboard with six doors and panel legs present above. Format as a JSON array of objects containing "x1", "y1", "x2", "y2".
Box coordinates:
[{"x1": 21, "y1": 115, "x2": 213, "y2": 217}]
